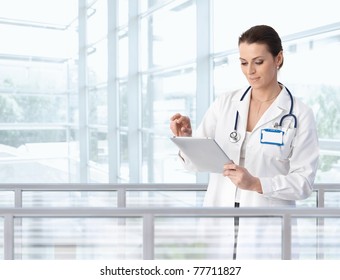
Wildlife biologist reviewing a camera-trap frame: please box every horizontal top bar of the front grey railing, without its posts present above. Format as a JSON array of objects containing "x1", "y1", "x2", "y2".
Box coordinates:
[{"x1": 0, "y1": 207, "x2": 340, "y2": 217}]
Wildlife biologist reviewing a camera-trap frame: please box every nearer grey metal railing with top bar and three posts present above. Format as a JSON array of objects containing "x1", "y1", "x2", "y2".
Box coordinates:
[{"x1": 0, "y1": 207, "x2": 340, "y2": 259}]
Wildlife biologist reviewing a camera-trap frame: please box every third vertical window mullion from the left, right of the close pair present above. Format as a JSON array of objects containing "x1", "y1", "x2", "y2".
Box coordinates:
[{"x1": 127, "y1": 0, "x2": 141, "y2": 182}]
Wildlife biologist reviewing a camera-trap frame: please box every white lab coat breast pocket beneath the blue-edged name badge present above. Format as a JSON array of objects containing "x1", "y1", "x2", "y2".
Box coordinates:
[{"x1": 261, "y1": 128, "x2": 295, "y2": 162}]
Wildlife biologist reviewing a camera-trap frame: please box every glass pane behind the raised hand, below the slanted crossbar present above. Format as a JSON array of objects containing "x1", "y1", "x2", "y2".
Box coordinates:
[{"x1": 142, "y1": 68, "x2": 196, "y2": 182}]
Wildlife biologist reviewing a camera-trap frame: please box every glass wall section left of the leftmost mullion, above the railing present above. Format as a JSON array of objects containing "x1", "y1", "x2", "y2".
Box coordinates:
[{"x1": 0, "y1": 0, "x2": 79, "y2": 183}]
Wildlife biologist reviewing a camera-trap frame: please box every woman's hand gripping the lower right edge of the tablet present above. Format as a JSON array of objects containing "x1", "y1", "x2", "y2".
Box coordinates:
[{"x1": 223, "y1": 163, "x2": 262, "y2": 193}]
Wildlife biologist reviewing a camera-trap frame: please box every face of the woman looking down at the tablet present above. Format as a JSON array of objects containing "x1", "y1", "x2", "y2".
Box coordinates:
[{"x1": 239, "y1": 43, "x2": 283, "y2": 89}]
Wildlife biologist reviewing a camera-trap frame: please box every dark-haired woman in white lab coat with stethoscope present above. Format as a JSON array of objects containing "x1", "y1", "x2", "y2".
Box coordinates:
[{"x1": 170, "y1": 25, "x2": 319, "y2": 256}]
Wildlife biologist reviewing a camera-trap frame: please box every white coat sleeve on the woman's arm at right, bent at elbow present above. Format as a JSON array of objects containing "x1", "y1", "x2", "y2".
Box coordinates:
[{"x1": 260, "y1": 106, "x2": 319, "y2": 200}]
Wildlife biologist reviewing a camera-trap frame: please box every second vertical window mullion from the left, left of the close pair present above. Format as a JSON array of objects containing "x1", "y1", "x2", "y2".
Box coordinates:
[{"x1": 107, "y1": 0, "x2": 119, "y2": 183}]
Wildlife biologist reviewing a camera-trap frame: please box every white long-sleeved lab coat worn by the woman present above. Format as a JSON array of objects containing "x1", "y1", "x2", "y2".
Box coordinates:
[{"x1": 183, "y1": 87, "x2": 319, "y2": 258}]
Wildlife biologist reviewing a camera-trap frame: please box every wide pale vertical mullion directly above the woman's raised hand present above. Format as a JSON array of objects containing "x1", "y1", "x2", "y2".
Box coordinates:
[{"x1": 196, "y1": 0, "x2": 212, "y2": 183}]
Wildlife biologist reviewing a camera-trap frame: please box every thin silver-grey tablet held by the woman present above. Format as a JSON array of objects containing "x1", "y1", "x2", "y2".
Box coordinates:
[{"x1": 170, "y1": 136, "x2": 232, "y2": 173}]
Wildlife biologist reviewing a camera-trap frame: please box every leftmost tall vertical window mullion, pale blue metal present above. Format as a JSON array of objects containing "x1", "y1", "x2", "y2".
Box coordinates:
[{"x1": 78, "y1": 0, "x2": 89, "y2": 183}]
